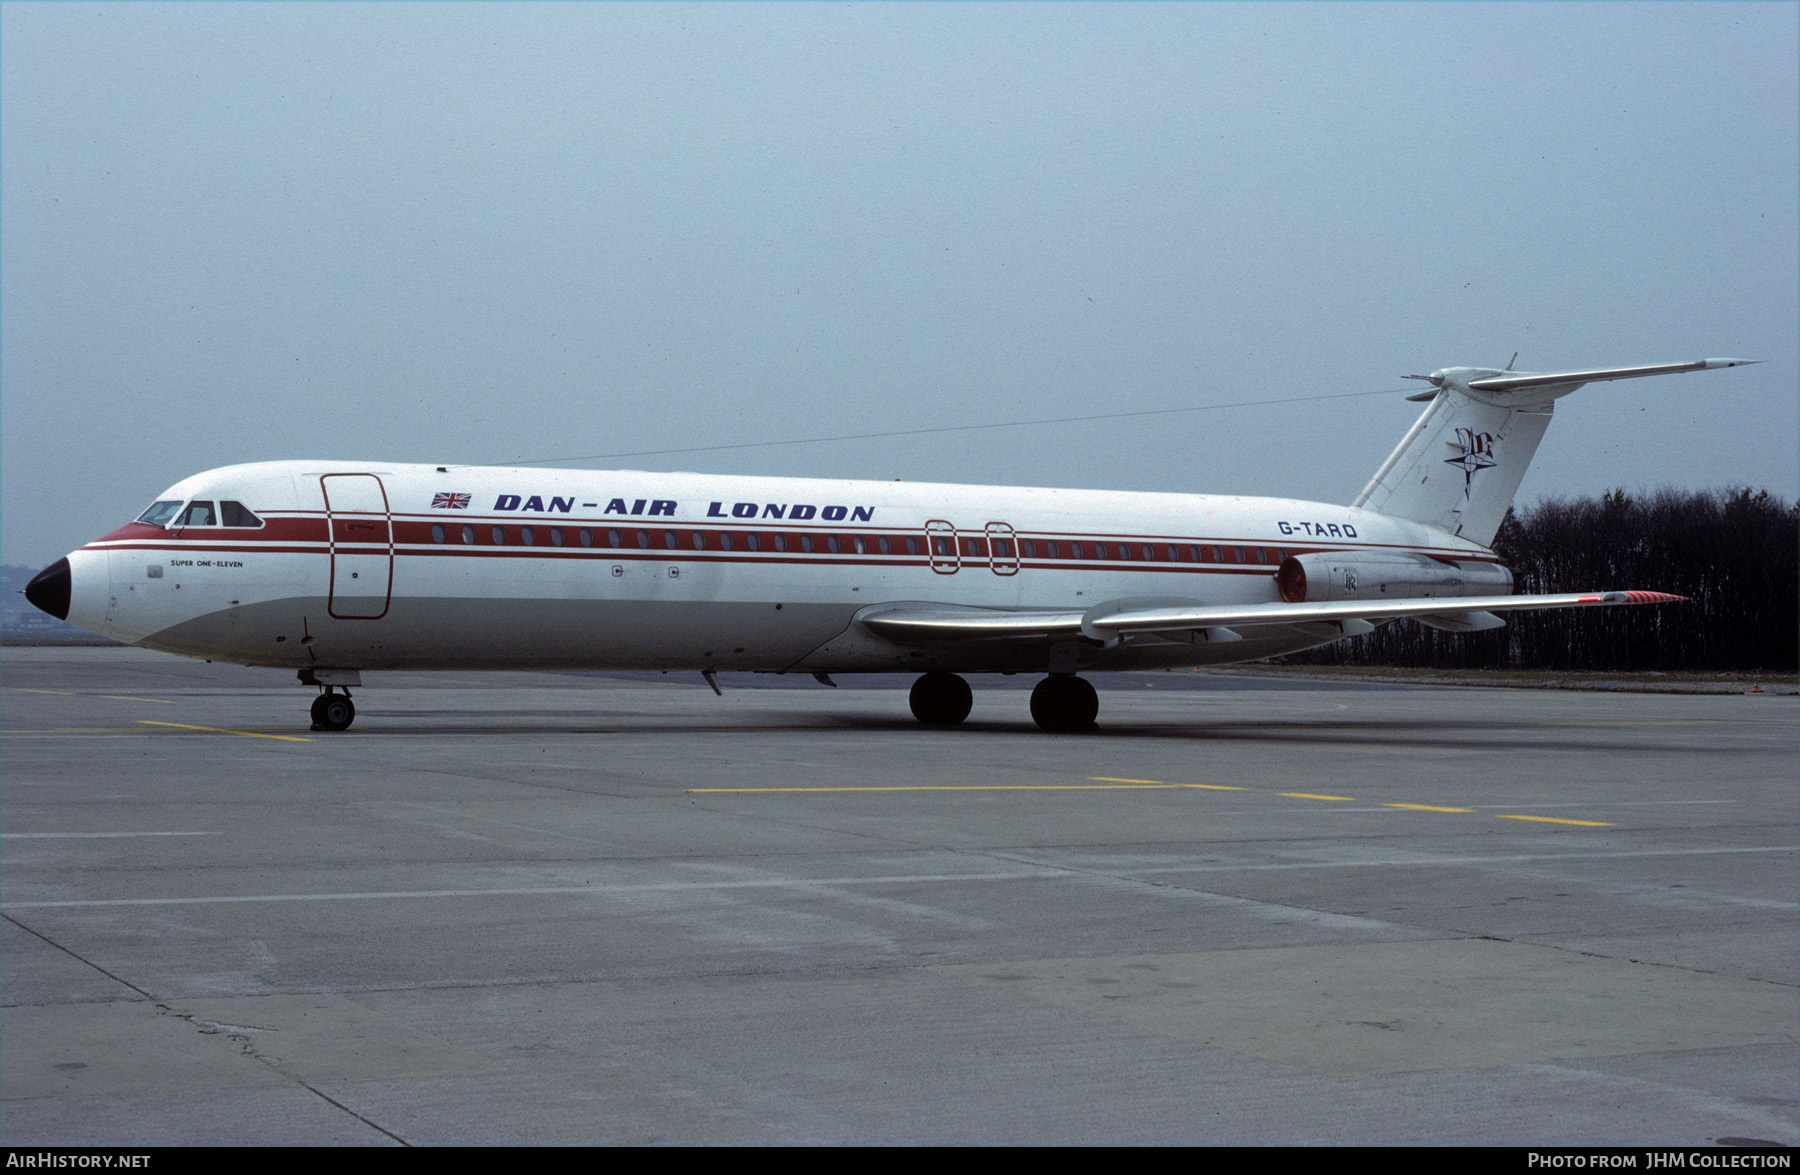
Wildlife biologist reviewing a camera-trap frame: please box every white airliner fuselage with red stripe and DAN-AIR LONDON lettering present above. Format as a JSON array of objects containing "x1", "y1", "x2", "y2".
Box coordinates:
[{"x1": 56, "y1": 461, "x2": 1494, "y2": 673}]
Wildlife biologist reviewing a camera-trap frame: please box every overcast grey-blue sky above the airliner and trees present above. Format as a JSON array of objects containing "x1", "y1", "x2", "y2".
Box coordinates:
[{"x1": 0, "y1": 4, "x2": 1800, "y2": 563}]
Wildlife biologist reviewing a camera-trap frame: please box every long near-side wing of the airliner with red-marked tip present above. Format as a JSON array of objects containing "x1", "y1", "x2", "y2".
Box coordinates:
[{"x1": 857, "y1": 592, "x2": 1687, "y2": 644}]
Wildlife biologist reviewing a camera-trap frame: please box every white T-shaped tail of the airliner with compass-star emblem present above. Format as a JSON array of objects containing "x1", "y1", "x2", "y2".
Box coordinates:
[{"x1": 1352, "y1": 360, "x2": 1760, "y2": 547}]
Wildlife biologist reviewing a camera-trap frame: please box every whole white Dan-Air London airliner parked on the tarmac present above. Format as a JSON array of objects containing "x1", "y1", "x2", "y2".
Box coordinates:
[{"x1": 25, "y1": 360, "x2": 1755, "y2": 731}]
